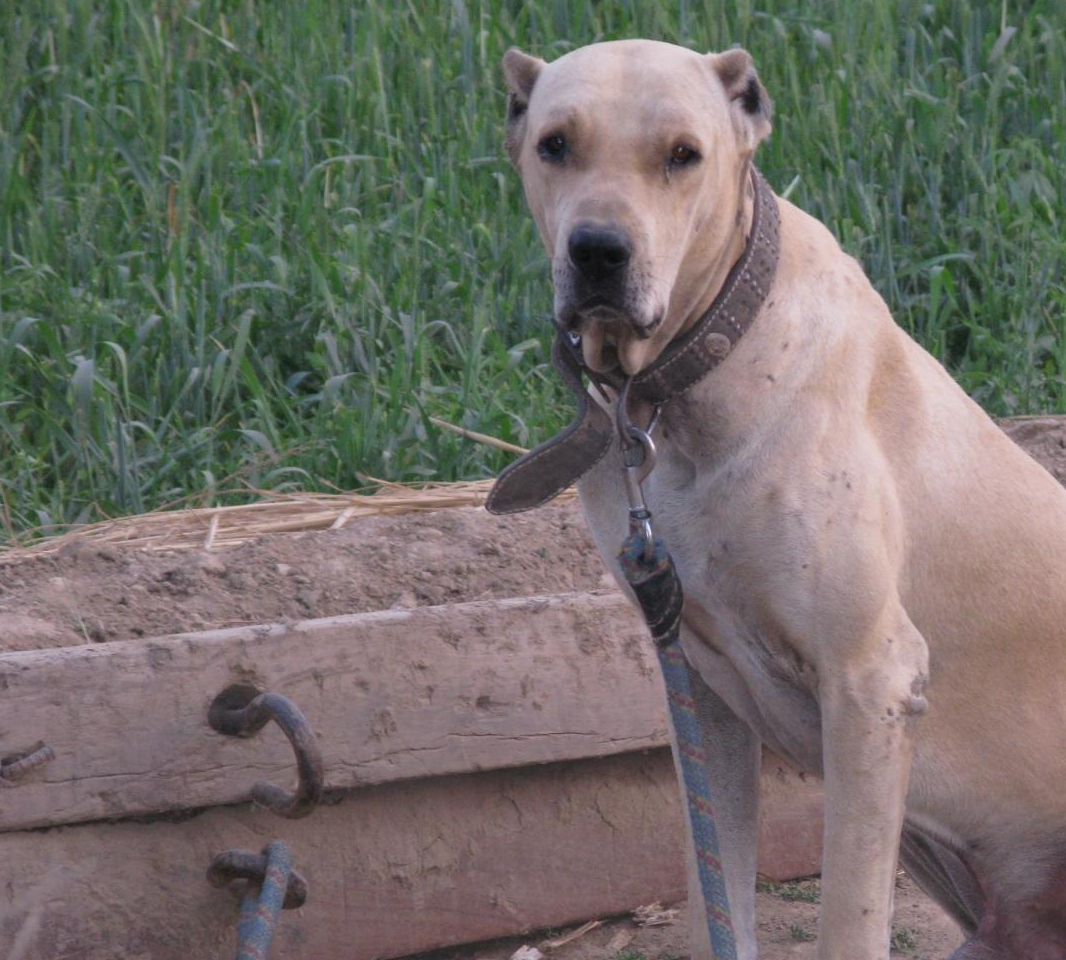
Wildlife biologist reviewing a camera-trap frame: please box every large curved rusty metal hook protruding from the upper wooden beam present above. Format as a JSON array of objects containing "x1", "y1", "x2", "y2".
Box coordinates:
[{"x1": 208, "y1": 685, "x2": 325, "y2": 819}]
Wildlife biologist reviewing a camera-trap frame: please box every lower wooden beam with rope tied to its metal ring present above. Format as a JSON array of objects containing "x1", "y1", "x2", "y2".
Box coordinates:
[{"x1": 0, "y1": 749, "x2": 684, "y2": 960}]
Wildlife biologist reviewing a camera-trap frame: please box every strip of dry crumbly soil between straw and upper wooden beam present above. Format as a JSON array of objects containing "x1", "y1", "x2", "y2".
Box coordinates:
[{"x1": 0, "y1": 503, "x2": 614, "y2": 651}]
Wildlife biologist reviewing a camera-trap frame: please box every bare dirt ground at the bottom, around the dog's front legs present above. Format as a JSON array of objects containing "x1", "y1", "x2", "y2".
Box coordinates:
[{"x1": 413, "y1": 873, "x2": 962, "y2": 960}]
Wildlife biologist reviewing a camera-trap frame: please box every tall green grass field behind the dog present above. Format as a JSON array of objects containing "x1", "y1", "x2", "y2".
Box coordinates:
[{"x1": 0, "y1": 0, "x2": 1066, "y2": 542}]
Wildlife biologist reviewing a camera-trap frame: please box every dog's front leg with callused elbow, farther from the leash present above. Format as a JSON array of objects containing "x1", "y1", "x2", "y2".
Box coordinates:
[{"x1": 819, "y1": 602, "x2": 928, "y2": 960}]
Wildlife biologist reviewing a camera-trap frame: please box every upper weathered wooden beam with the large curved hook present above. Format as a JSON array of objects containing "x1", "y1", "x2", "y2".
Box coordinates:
[{"x1": 0, "y1": 593, "x2": 667, "y2": 832}]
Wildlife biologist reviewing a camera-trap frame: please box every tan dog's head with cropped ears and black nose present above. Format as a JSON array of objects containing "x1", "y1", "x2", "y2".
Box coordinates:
[{"x1": 503, "y1": 40, "x2": 770, "y2": 375}]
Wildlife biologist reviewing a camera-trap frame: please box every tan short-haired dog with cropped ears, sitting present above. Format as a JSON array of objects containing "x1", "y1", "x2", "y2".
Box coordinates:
[{"x1": 496, "y1": 40, "x2": 1066, "y2": 960}]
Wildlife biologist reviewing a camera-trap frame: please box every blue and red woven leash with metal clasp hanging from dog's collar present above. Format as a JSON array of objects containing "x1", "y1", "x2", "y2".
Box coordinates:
[{"x1": 618, "y1": 390, "x2": 737, "y2": 960}]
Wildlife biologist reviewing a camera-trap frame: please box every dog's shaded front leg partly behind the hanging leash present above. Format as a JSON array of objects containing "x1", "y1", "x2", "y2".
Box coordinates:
[{"x1": 681, "y1": 669, "x2": 761, "y2": 960}]
